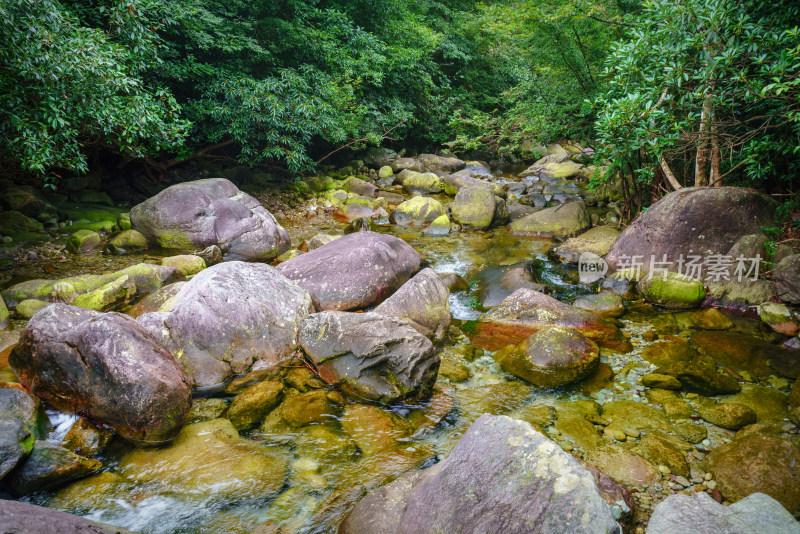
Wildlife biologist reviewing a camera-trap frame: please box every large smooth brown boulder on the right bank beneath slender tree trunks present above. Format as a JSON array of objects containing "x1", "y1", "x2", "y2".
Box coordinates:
[{"x1": 606, "y1": 187, "x2": 777, "y2": 272}]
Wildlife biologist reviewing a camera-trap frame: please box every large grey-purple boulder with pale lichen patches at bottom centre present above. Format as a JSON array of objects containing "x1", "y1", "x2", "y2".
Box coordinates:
[{"x1": 339, "y1": 414, "x2": 622, "y2": 534}]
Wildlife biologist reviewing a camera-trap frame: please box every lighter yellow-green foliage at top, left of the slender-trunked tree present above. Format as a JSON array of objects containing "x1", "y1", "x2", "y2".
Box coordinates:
[{"x1": 451, "y1": 0, "x2": 638, "y2": 154}]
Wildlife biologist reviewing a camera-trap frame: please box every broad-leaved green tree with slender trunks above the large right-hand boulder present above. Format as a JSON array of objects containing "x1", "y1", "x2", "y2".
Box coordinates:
[{"x1": 595, "y1": 0, "x2": 800, "y2": 191}]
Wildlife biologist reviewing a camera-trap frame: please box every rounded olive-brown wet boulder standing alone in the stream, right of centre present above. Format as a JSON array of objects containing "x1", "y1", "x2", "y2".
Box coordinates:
[{"x1": 494, "y1": 327, "x2": 600, "y2": 387}]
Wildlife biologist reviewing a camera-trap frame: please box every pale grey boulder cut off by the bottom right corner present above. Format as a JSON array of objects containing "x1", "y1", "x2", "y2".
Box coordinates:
[{"x1": 647, "y1": 491, "x2": 800, "y2": 534}]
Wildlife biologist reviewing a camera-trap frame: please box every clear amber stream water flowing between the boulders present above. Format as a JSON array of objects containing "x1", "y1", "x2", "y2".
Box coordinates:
[{"x1": 3, "y1": 168, "x2": 796, "y2": 534}]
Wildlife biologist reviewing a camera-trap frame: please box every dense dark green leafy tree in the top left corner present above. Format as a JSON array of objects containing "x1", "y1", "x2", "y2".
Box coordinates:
[{"x1": 0, "y1": 0, "x2": 188, "y2": 183}]
